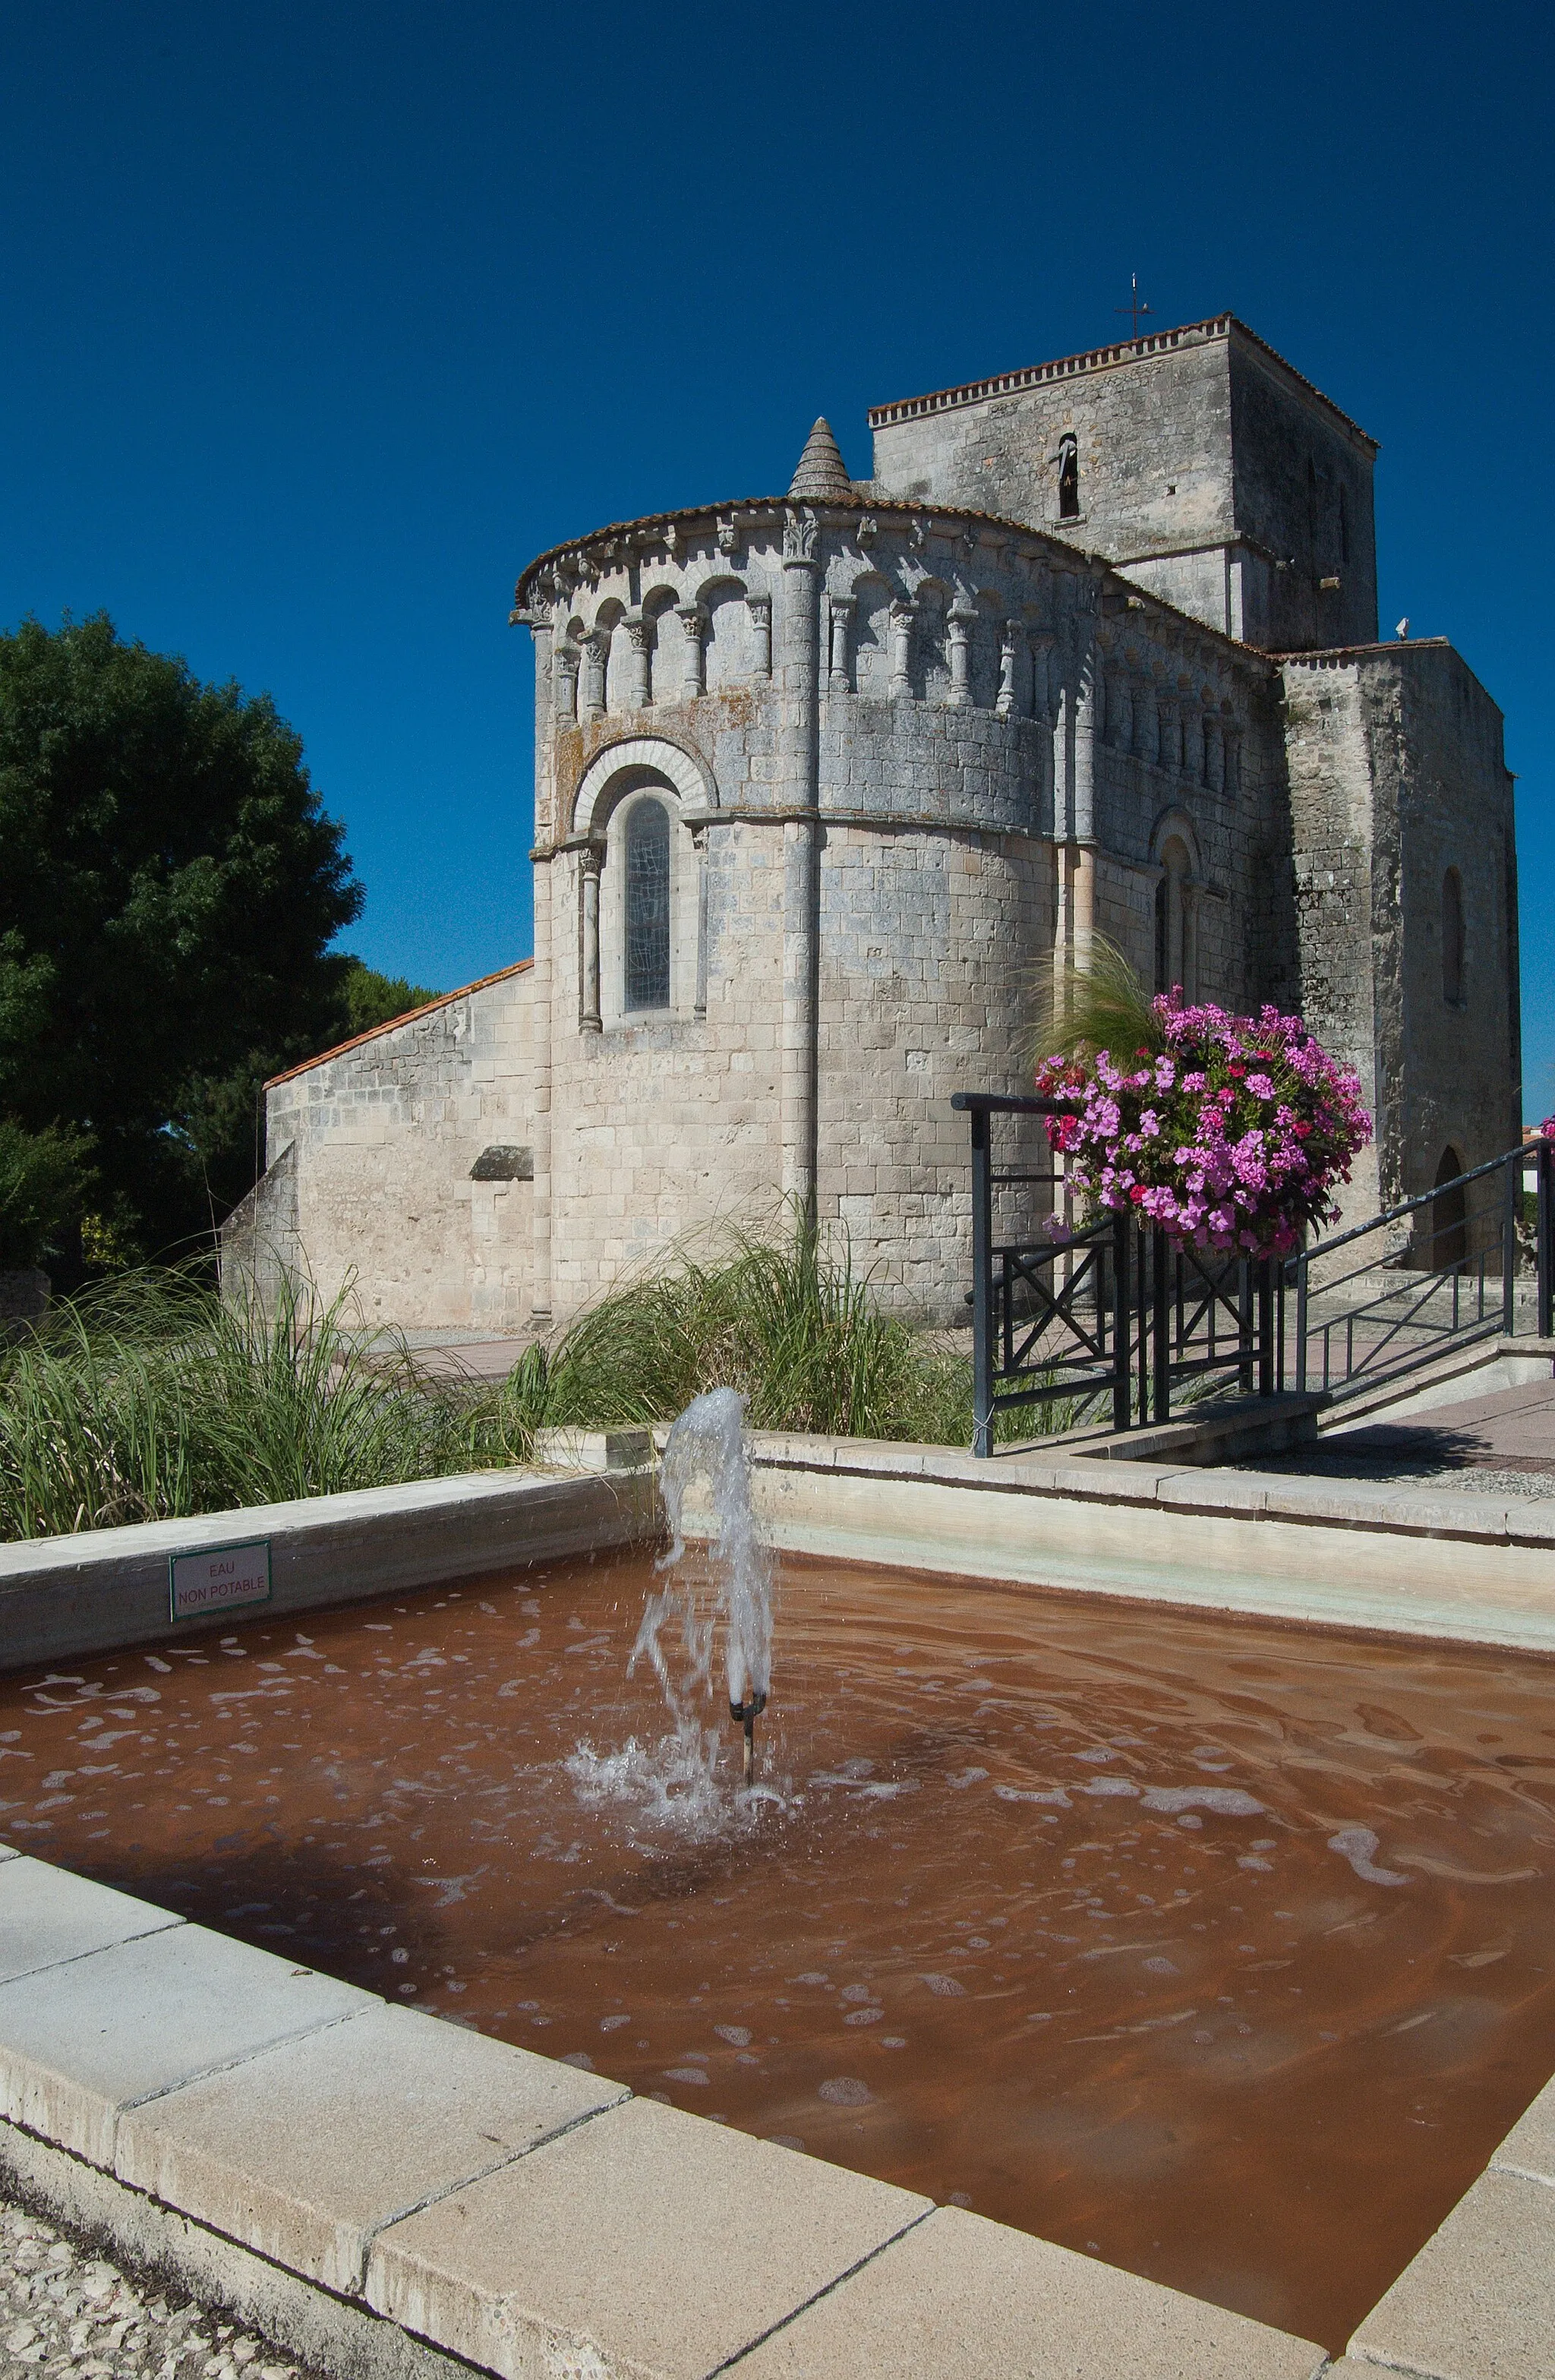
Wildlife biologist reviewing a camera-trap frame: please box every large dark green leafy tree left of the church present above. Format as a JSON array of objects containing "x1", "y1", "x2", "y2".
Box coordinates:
[{"x1": 0, "y1": 614, "x2": 362, "y2": 1276}]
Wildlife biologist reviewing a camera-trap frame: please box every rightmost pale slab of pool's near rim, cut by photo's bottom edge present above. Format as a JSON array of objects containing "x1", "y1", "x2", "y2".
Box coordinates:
[{"x1": 733, "y1": 2206, "x2": 1329, "y2": 2380}]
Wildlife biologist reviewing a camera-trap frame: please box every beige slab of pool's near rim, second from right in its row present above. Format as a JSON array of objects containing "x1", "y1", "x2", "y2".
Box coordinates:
[{"x1": 367, "y1": 2099, "x2": 931, "y2": 2380}]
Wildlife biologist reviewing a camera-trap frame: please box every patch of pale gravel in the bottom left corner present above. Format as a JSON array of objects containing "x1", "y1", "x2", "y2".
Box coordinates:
[{"x1": 0, "y1": 2202, "x2": 317, "y2": 2380}]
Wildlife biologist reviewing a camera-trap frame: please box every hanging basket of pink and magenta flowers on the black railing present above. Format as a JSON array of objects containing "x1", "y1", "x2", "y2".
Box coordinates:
[{"x1": 1036, "y1": 952, "x2": 1372, "y2": 1257}]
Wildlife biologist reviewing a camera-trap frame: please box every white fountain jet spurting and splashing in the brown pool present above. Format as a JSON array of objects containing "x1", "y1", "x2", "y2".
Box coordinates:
[{"x1": 564, "y1": 1387, "x2": 784, "y2": 1837}]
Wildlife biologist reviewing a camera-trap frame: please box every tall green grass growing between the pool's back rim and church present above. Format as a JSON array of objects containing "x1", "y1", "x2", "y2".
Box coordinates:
[{"x1": 0, "y1": 1216, "x2": 1081, "y2": 1538}]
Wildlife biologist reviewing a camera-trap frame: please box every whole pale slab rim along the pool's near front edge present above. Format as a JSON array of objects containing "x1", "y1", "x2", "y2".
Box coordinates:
[{"x1": 0, "y1": 1857, "x2": 1329, "y2": 2380}]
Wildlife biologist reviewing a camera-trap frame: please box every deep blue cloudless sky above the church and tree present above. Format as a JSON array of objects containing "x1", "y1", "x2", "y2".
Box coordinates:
[{"x1": 0, "y1": 0, "x2": 1555, "y2": 1116}]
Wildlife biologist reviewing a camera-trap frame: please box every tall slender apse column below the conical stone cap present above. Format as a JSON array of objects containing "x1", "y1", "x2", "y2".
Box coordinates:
[{"x1": 779, "y1": 507, "x2": 822, "y2": 1216}]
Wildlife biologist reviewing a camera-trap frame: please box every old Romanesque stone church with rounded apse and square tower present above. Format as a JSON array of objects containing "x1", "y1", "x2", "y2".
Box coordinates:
[{"x1": 224, "y1": 314, "x2": 1522, "y2": 1333}]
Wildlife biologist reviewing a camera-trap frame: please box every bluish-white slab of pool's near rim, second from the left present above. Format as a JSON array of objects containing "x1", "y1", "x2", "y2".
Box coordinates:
[{"x1": 0, "y1": 1904, "x2": 381, "y2": 2168}]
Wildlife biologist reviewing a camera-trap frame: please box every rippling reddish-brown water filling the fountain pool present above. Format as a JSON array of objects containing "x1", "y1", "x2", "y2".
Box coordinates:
[{"x1": 0, "y1": 1557, "x2": 1555, "y2": 2347}]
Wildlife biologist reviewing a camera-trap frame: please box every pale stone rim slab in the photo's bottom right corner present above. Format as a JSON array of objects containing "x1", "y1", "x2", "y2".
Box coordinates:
[{"x1": 1350, "y1": 2170, "x2": 1555, "y2": 2380}]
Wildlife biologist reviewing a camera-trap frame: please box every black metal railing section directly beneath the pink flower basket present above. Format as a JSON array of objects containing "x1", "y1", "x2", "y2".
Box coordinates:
[{"x1": 950, "y1": 1090, "x2": 1286, "y2": 1454}]
